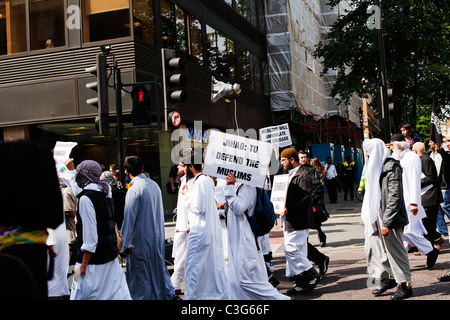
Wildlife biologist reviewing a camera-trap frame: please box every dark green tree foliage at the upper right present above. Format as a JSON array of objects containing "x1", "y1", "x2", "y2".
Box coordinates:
[{"x1": 315, "y1": 0, "x2": 450, "y2": 135}]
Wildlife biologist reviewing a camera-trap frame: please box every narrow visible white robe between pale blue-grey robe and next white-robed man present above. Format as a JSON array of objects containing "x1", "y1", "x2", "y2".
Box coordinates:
[{"x1": 170, "y1": 176, "x2": 192, "y2": 290}]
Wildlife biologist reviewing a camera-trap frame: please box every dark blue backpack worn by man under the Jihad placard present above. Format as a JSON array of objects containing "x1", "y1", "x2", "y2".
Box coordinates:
[{"x1": 236, "y1": 185, "x2": 275, "y2": 237}]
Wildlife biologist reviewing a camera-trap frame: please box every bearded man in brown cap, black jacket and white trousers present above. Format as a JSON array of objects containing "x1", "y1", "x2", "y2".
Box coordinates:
[{"x1": 280, "y1": 148, "x2": 322, "y2": 296}]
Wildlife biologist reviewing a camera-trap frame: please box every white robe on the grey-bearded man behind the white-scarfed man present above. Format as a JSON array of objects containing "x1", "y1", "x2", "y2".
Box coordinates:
[{"x1": 399, "y1": 149, "x2": 433, "y2": 254}]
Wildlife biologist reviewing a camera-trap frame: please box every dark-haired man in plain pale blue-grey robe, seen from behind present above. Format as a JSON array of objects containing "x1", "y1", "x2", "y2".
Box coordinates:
[{"x1": 121, "y1": 156, "x2": 177, "y2": 300}]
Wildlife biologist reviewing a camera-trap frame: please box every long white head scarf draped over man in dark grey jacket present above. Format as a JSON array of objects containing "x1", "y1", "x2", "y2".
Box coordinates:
[{"x1": 361, "y1": 138, "x2": 390, "y2": 235}]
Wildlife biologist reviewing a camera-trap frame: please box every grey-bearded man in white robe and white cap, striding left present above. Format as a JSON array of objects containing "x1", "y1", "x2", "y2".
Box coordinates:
[{"x1": 391, "y1": 135, "x2": 439, "y2": 268}]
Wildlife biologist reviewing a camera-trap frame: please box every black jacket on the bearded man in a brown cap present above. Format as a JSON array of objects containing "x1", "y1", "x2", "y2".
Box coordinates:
[{"x1": 285, "y1": 167, "x2": 314, "y2": 231}]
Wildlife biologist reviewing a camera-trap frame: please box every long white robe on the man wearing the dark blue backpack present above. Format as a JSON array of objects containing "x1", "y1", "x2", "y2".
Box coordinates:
[{"x1": 224, "y1": 185, "x2": 290, "y2": 300}]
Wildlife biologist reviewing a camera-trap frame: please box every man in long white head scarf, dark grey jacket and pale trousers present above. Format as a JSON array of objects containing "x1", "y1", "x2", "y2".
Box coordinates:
[{"x1": 361, "y1": 139, "x2": 412, "y2": 300}]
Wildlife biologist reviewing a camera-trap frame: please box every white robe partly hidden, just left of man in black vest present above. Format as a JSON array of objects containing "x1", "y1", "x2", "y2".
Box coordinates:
[{"x1": 47, "y1": 212, "x2": 70, "y2": 297}]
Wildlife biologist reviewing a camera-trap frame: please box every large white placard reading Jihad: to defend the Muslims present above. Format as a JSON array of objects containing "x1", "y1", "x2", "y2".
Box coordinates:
[{"x1": 203, "y1": 131, "x2": 272, "y2": 188}]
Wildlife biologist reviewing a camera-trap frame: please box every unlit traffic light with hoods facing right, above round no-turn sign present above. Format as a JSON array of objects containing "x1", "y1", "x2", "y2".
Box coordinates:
[{"x1": 162, "y1": 48, "x2": 187, "y2": 112}]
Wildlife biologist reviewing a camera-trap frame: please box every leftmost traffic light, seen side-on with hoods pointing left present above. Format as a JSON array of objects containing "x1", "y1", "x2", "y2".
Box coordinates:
[{"x1": 85, "y1": 54, "x2": 109, "y2": 136}]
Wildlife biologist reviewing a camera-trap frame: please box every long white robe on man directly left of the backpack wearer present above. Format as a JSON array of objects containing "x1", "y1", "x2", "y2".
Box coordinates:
[{"x1": 184, "y1": 175, "x2": 227, "y2": 300}]
